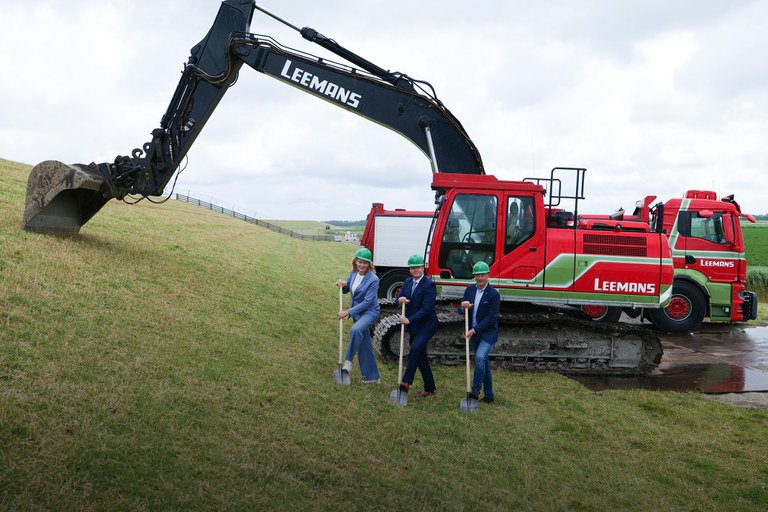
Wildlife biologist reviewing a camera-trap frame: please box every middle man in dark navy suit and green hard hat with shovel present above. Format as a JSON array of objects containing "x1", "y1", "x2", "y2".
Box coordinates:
[{"x1": 397, "y1": 254, "x2": 438, "y2": 397}]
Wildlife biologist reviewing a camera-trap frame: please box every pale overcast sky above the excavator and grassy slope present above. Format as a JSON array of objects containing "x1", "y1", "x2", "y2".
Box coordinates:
[{"x1": 0, "y1": 0, "x2": 768, "y2": 220}]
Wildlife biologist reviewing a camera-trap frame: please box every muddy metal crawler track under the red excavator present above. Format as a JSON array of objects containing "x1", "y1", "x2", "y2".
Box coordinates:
[{"x1": 373, "y1": 300, "x2": 662, "y2": 376}]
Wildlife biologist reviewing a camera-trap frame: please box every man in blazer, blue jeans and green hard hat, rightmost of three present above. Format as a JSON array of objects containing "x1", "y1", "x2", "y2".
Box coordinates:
[{"x1": 459, "y1": 261, "x2": 501, "y2": 403}]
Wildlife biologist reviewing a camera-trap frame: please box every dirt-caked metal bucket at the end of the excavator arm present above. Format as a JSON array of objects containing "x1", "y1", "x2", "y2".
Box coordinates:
[{"x1": 24, "y1": 160, "x2": 109, "y2": 234}]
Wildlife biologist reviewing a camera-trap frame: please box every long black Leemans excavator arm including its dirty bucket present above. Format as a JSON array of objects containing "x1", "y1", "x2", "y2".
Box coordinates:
[{"x1": 24, "y1": 0, "x2": 484, "y2": 233}]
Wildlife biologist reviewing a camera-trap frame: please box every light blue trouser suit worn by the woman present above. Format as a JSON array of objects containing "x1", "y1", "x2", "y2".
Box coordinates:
[{"x1": 341, "y1": 271, "x2": 380, "y2": 380}]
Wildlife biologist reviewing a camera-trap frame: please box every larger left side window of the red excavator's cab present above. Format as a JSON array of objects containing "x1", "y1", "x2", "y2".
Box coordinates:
[{"x1": 438, "y1": 194, "x2": 497, "y2": 279}]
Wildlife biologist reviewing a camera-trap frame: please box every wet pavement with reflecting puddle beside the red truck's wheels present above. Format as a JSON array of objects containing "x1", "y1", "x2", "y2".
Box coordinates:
[{"x1": 572, "y1": 324, "x2": 768, "y2": 393}]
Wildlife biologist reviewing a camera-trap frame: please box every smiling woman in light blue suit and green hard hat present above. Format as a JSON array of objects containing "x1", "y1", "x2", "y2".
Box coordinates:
[{"x1": 336, "y1": 247, "x2": 381, "y2": 384}]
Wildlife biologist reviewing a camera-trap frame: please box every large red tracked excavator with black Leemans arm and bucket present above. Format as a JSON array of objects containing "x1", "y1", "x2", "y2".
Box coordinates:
[{"x1": 24, "y1": 0, "x2": 673, "y2": 375}]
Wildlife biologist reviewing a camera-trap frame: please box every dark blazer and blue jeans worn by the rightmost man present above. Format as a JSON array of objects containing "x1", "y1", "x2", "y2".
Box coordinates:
[{"x1": 459, "y1": 284, "x2": 501, "y2": 398}]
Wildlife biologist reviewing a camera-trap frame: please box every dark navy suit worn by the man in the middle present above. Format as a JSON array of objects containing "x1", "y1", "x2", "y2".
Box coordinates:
[{"x1": 400, "y1": 276, "x2": 438, "y2": 393}]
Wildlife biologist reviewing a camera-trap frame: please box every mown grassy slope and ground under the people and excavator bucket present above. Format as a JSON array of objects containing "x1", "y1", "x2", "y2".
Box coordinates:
[{"x1": 0, "y1": 160, "x2": 768, "y2": 511}]
